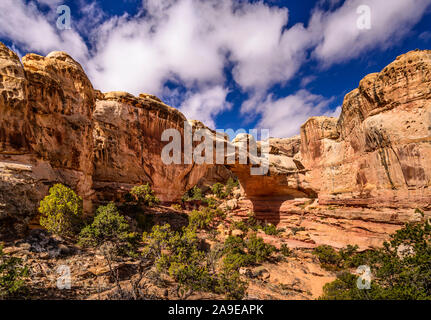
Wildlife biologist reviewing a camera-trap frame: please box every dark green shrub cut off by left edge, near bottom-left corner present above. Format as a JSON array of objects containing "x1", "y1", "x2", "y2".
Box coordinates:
[{"x1": 0, "y1": 245, "x2": 28, "y2": 300}]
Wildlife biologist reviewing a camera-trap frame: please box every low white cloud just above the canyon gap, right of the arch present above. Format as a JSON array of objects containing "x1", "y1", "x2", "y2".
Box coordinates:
[{"x1": 258, "y1": 90, "x2": 332, "y2": 138}]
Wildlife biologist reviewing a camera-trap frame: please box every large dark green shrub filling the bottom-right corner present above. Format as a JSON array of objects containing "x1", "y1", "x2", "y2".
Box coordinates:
[{"x1": 321, "y1": 222, "x2": 431, "y2": 300}]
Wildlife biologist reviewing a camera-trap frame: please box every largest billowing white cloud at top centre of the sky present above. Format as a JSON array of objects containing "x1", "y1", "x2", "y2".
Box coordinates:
[{"x1": 87, "y1": 0, "x2": 310, "y2": 93}]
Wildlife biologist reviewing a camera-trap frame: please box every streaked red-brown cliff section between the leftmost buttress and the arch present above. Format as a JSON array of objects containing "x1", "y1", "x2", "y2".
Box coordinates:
[{"x1": 93, "y1": 92, "x2": 215, "y2": 201}]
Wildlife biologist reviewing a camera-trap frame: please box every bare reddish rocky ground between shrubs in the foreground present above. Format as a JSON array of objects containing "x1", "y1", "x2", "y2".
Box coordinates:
[{"x1": 3, "y1": 200, "x2": 335, "y2": 300}]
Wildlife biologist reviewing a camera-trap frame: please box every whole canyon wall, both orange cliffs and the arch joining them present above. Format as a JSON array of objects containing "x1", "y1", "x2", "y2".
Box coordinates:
[{"x1": 0, "y1": 43, "x2": 431, "y2": 248}]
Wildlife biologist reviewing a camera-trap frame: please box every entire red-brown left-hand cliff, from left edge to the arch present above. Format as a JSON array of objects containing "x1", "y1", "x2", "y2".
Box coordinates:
[{"x1": 0, "y1": 43, "x2": 223, "y2": 234}]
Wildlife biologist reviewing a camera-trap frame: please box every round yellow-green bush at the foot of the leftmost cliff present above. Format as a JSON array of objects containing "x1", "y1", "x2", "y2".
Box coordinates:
[{"x1": 39, "y1": 184, "x2": 83, "y2": 236}]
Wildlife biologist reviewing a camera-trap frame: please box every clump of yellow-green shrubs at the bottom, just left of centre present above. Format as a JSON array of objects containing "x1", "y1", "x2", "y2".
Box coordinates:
[{"x1": 143, "y1": 225, "x2": 247, "y2": 299}]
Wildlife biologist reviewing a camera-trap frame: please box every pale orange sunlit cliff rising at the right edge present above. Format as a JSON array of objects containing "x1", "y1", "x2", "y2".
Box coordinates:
[{"x1": 301, "y1": 51, "x2": 431, "y2": 208}]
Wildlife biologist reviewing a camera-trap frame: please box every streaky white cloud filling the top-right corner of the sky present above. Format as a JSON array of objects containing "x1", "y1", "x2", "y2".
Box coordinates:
[{"x1": 310, "y1": 0, "x2": 431, "y2": 66}]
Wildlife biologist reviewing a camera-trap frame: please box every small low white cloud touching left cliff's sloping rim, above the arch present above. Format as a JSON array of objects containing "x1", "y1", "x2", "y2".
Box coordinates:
[{"x1": 180, "y1": 86, "x2": 232, "y2": 129}]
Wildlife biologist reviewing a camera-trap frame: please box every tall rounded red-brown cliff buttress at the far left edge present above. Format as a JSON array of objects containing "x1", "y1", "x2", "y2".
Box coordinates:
[{"x1": 0, "y1": 43, "x2": 95, "y2": 232}]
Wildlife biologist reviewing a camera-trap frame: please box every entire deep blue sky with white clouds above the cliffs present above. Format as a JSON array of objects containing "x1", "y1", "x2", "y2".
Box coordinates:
[{"x1": 0, "y1": 0, "x2": 431, "y2": 137}]
